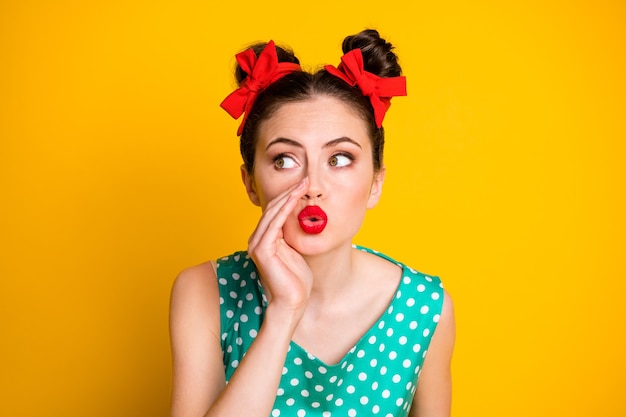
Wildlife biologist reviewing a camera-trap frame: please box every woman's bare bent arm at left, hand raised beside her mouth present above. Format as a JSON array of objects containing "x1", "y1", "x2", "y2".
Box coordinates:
[{"x1": 170, "y1": 177, "x2": 312, "y2": 417}]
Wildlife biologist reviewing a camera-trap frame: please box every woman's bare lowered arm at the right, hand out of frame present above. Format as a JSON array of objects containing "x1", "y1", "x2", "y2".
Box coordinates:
[{"x1": 410, "y1": 291, "x2": 456, "y2": 417}]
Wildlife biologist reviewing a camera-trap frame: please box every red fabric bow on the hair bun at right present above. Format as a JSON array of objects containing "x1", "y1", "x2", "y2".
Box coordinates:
[{"x1": 324, "y1": 48, "x2": 406, "y2": 127}]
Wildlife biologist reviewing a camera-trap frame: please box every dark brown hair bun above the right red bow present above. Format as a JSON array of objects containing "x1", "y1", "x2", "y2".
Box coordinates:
[{"x1": 341, "y1": 29, "x2": 402, "y2": 77}]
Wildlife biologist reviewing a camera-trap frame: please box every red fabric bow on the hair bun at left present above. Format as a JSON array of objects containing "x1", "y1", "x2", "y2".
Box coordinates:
[{"x1": 220, "y1": 41, "x2": 300, "y2": 136}]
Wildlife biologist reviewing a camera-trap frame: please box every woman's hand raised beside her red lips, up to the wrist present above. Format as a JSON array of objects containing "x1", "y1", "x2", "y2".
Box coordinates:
[{"x1": 248, "y1": 178, "x2": 313, "y2": 314}]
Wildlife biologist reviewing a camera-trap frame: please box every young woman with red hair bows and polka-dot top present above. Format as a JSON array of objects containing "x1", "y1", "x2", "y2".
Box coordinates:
[{"x1": 171, "y1": 30, "x2": 455, "y2": 417}]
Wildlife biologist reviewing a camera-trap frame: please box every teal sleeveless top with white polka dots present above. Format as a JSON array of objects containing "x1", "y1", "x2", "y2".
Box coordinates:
[{"x1": 217, "y1": 246, "x2": 443, "y2": 417}]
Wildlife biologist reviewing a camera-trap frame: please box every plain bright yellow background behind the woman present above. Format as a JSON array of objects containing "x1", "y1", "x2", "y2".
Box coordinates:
[{"x1": 0, "y1": 0, "x2": 626, "y2": 417}]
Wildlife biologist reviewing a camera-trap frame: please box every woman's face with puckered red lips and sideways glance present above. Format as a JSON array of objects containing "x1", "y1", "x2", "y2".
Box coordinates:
[{"x1": 242, "y1": 96, "x2": 384, "y2": 255}]
